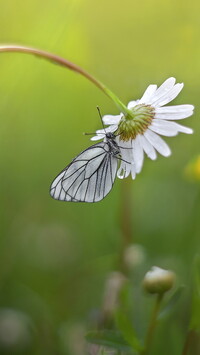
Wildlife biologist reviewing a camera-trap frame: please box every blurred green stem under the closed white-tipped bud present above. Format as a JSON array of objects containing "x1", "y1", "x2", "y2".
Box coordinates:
[{"x1": 141, "y1": 293, "x2": 163, "y2": 355}]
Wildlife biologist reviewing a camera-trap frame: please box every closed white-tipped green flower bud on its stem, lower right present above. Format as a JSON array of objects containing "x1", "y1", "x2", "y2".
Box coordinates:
[{"x1": 143, "y1": 266, "x2": 175, "y2": 294}]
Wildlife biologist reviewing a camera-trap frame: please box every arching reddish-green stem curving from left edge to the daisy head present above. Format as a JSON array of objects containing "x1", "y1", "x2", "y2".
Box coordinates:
[{"x1": 0, "y1": 44, "x2": 128, "y2": 113}]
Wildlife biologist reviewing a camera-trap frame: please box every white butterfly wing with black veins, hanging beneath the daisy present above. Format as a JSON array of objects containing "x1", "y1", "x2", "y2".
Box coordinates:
[{"x1": 50, "y1": 142, "x2": 118, "y2": 202}]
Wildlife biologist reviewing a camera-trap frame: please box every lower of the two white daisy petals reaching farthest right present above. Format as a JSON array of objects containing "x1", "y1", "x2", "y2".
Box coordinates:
[{"x1": 149, "y1": 118, "x2": 193, "y2": 137}]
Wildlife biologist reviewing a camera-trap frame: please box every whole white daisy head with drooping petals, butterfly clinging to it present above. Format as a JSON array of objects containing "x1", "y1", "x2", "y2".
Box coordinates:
[{"x1": 91, "y1": 78, "x2": 194, "y2": 179}]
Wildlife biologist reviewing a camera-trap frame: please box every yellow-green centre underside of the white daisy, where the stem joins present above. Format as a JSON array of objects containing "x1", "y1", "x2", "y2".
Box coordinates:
[{"x1": 117, "y1": 104, "x2": 155, "y2": 141}]
